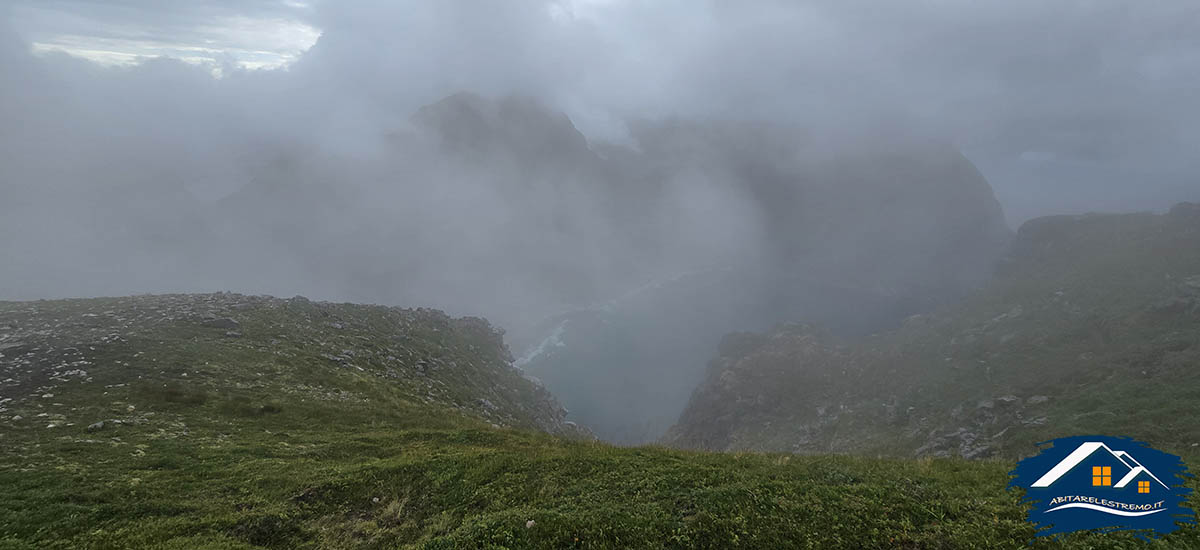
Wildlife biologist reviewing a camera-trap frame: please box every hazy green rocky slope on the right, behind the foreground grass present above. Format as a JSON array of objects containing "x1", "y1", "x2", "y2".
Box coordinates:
[{"x1": 666, "y1": 203, "x2": 1200, "y2": 458}]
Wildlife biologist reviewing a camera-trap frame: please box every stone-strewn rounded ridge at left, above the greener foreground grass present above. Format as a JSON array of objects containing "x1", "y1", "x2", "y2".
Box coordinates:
[{"x1": 0, "y1": 293, "x2": 586, "y2": 436}]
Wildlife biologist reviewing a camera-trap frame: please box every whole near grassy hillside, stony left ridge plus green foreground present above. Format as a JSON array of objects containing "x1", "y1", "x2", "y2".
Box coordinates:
[{"x1": 0, "y1": 294, "x2": 1200, "y2": 550}]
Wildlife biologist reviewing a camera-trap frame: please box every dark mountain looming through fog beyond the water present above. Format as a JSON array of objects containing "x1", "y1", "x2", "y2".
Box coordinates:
[{"x1": 412, "y1": 92, "x2": 1010, "y2": 305}]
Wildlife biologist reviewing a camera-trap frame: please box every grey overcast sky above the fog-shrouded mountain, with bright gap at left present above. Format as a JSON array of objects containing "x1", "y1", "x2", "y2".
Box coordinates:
[{"x1": 0, "y1": 0, "x2": 1200, "y2": 220}]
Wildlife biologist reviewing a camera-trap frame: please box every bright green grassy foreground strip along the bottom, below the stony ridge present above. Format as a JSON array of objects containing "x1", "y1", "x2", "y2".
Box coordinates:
[{"x1": 0, "y1": 412, "x2": 1200, "y2": 549}]
